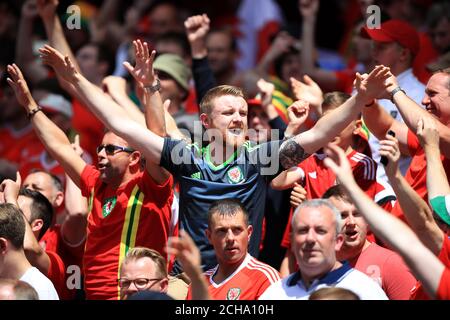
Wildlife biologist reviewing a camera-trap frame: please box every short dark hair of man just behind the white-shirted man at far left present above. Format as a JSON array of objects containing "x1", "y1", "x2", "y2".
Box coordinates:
[{"x1": 19, "y1": 188, "x2": 53, "y2": 240}]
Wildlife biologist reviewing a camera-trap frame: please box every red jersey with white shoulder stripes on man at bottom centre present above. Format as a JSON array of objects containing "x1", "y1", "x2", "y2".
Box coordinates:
[{"x1": 186, "y1": 254, "x2": 280, "y2": 300}]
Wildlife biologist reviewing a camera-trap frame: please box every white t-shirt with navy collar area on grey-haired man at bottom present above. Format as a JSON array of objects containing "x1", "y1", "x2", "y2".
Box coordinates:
[{"x1": 259, "y1": 263, "x2": 388, "y2": 300}]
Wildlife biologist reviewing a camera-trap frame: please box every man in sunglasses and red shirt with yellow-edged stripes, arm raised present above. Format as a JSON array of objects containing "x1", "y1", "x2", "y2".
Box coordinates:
[{"x1": 8, "y1": 55, "x2": 173, "y2": 299}]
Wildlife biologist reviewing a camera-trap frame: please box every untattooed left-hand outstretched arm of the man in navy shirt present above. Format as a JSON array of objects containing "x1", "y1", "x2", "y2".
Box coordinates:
[{"x1": 40, "y1": 46, "x2": 164, "y2": 165}]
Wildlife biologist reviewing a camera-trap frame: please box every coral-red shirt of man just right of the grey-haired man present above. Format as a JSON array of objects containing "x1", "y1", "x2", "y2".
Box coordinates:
[{"x1": 351, "y1": 243, "x2": 416, "y2": 300}]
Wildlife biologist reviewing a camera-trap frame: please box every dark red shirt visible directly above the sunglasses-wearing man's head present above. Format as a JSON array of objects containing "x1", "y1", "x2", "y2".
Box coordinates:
[{"x1": 71, "y1": 99, "x2": 104, "y2": 163}]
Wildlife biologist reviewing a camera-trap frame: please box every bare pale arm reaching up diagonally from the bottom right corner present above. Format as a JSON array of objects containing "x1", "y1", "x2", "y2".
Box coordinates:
[{"x1": 325, "y1": 144, "x2": 445, "y2": 297}]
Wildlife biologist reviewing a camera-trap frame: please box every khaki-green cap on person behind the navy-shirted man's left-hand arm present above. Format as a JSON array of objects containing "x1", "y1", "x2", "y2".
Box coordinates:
[{"x1": 153, "y1": 53, "x2": 191, "y2": 91}]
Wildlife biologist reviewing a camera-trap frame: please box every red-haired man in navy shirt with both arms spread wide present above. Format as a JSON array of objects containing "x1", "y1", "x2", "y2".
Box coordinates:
[{"x1": 41, "y1": 46, "x2": 389, "y2": 270}]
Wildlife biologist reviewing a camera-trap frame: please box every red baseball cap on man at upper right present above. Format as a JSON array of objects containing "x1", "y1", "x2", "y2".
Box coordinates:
[{"x1": 361, "y1": 19, "x2": 420, "y2": 55}]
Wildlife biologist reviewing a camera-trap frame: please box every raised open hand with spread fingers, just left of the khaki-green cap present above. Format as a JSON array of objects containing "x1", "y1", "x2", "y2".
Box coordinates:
[{"x1": 123, "y1": 40, "x2": 156, "y2": 87}]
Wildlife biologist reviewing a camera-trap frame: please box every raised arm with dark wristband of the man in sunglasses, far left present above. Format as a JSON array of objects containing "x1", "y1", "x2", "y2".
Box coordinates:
[{"x1": 8, "y1": 64, "x2": 86, "y2": 186}]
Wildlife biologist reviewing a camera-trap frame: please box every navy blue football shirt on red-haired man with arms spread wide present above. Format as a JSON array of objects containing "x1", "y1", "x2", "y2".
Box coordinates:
[{"x1": 160, "y1": 138, "x2": 282, "y2": 270}]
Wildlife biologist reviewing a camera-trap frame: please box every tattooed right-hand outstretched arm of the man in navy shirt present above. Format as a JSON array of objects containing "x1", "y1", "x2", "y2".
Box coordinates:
[{"x1": 280, "y1": 66, "x2": 389, "y2": 169}]
